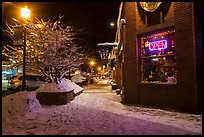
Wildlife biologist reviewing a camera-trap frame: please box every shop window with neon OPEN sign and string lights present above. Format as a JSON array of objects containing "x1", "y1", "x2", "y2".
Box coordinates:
[{"x1": 139, "y1": 29, "x2": 177, "y2": 84}]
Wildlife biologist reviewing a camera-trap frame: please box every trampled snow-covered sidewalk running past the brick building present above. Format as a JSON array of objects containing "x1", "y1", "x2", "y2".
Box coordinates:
[{"x1": 2, "y1": 80, "x2": 202, "y2": 135}]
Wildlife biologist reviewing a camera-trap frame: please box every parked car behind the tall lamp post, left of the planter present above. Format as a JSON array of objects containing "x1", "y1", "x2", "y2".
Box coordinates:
[{"x1": 7, "y1": 74, "x2": 46, "y2": 92}]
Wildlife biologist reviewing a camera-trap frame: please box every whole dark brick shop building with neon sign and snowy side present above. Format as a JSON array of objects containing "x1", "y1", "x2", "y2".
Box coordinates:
[{"x1": 111, "y1": 2, "x2": 202, "y2": 114}]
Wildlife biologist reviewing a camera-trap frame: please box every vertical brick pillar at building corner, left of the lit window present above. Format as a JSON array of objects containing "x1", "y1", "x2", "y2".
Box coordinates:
[{"x1": 123, "y1": 2, "x2": 138, "y2": 103}]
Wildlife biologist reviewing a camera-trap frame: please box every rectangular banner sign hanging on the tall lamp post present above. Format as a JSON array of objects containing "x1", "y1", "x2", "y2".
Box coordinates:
[{"x1": 13, "y1": 26, "x2": 23, "y2": 46}]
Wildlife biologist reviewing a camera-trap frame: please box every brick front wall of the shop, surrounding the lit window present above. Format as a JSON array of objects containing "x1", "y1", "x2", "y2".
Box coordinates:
[{"x1": 119, "y1": 2, "x2": 202, "y2": 113}]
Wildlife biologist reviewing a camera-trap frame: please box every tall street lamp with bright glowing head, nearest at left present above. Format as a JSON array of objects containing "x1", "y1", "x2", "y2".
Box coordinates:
[{"x1": 21, "y1": 7, "x2": 31, "y2": 91}]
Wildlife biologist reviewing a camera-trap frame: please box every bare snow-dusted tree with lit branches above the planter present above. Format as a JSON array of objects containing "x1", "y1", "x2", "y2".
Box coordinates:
[{"x1": 2, "y1": 16, "x2": 86, "y2": 83}]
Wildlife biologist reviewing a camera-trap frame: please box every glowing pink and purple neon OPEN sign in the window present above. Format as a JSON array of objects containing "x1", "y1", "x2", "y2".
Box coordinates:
[{"x1": 149, "y1": 40, "x2": 167, "y2": 51}]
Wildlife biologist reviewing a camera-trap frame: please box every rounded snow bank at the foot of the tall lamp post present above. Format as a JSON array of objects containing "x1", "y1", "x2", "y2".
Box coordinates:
[{"x1": 2, "y1": 91, "x2": 41, "y2": 120}]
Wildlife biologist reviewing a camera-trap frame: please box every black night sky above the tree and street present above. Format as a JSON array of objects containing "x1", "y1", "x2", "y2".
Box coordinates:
[{"x1": 2, "y1": 2, "x2": 120, "y2": 60}]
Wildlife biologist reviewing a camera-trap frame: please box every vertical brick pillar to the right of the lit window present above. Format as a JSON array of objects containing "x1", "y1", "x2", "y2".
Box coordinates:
[{"x1": 174, "y1": 2, "x2": 196, "y2": 111}]
